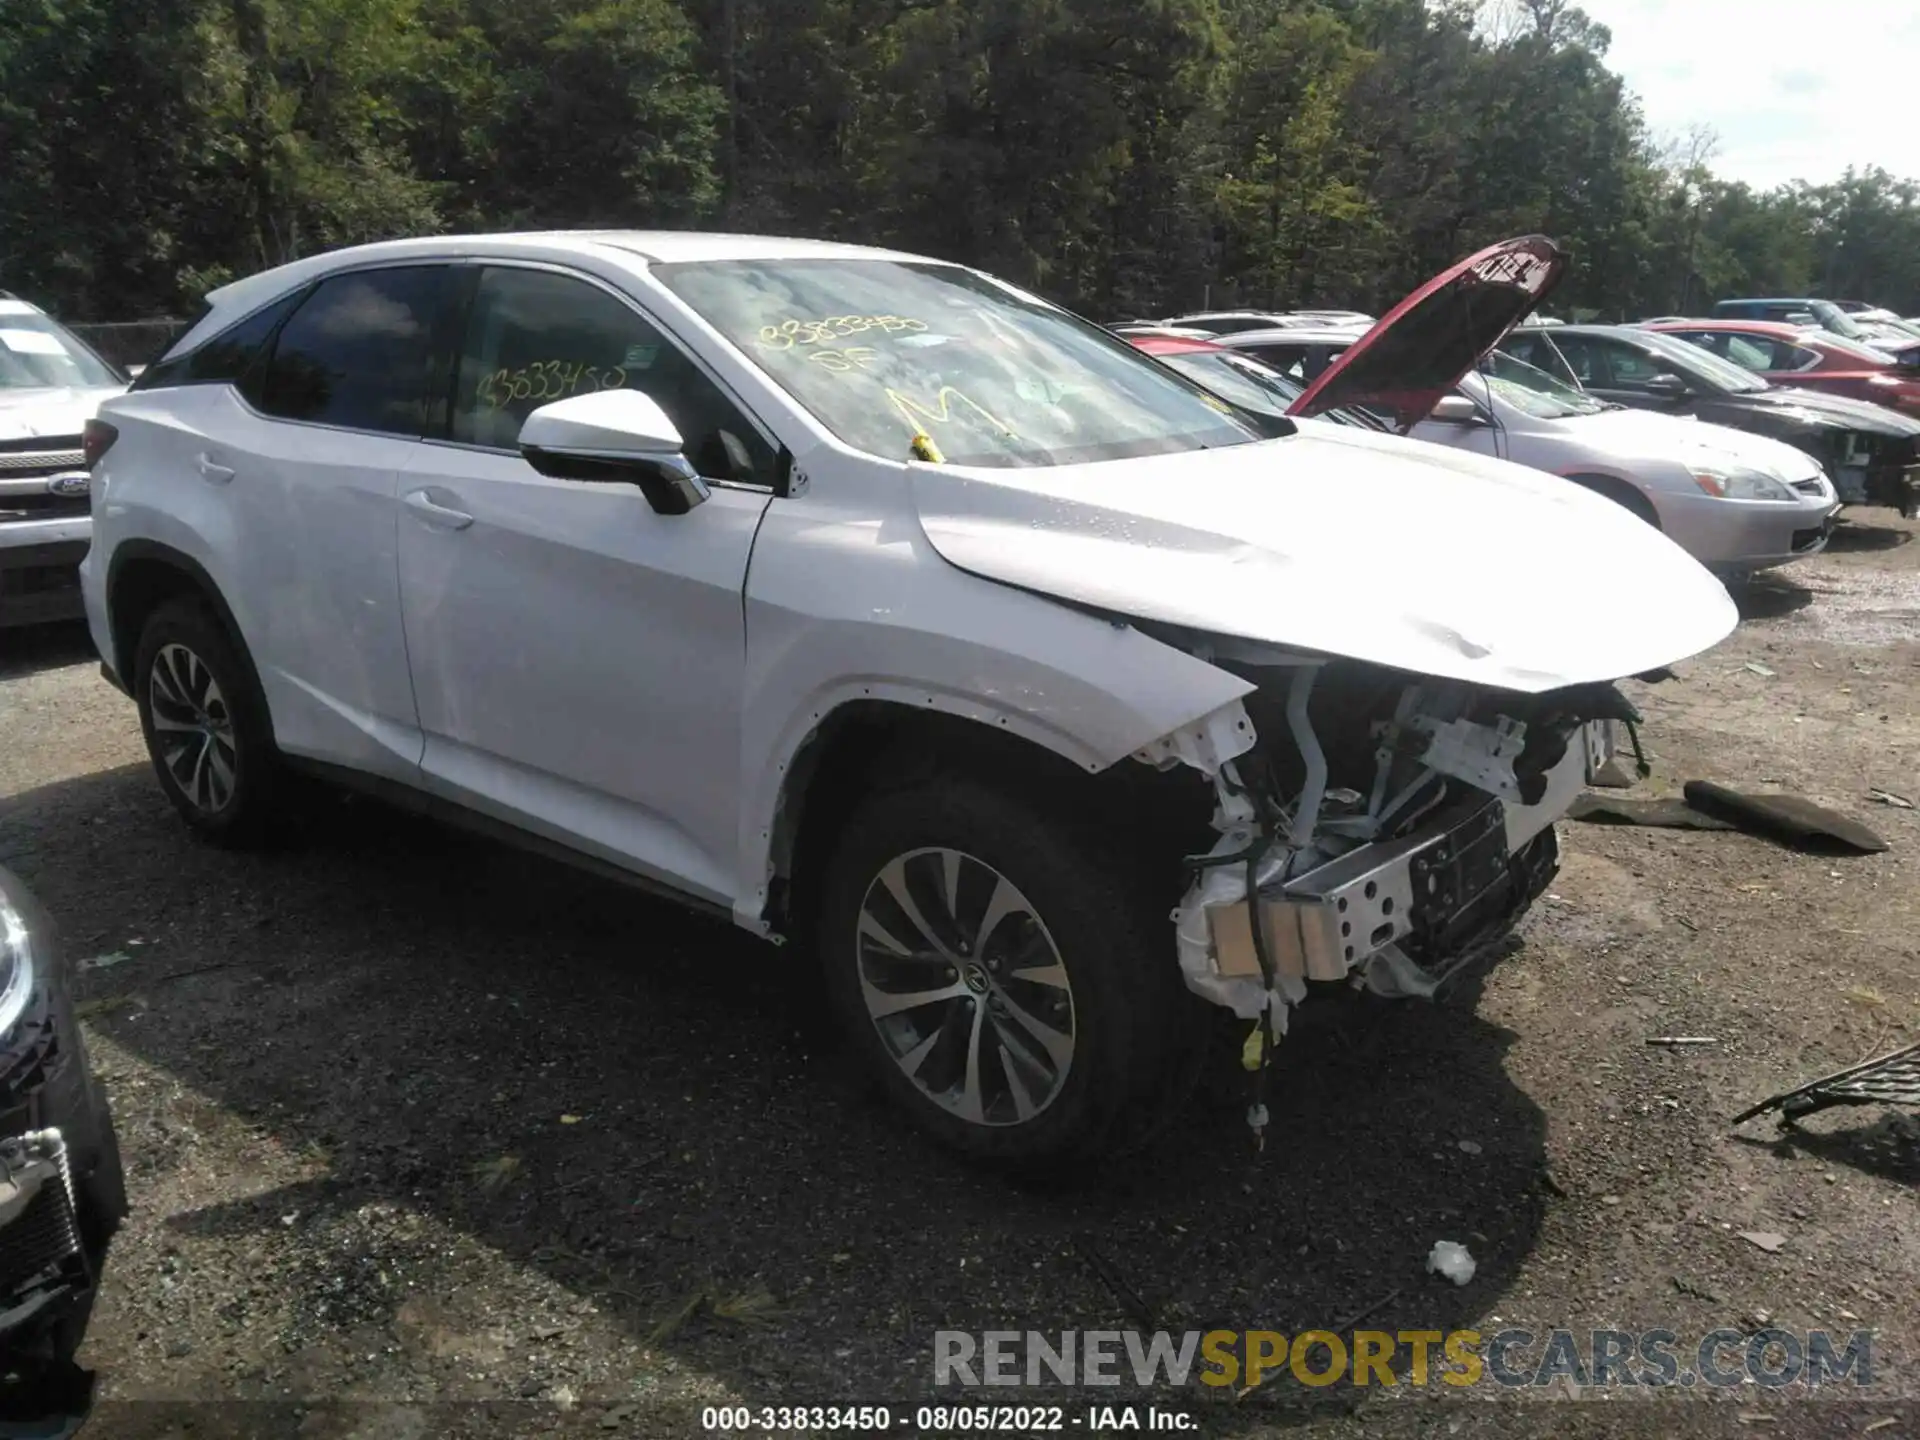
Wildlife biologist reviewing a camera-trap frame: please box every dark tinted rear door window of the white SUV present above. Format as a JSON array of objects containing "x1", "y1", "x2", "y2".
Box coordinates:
[{"x1": 257, "y1": 265, "x2": 449, "y2": 436}]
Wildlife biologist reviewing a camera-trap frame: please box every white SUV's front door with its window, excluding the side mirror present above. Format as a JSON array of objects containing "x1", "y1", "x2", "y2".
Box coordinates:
[{"x1": 399, "y1": 265, "x2": 776, "y2": 904}]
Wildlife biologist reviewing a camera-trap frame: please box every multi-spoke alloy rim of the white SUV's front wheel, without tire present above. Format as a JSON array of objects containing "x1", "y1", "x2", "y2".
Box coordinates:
[{"x1": 854, "y1": 849, "x2": 1075, "y2": 1125}]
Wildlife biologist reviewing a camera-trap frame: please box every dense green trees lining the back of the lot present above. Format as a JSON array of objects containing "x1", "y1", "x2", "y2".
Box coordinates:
[{"x1": 0, "y1": 0, "x2": 1920, "y2": 319}]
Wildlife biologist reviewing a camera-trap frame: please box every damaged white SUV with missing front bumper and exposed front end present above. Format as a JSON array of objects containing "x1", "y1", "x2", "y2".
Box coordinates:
[{"x1": 84, "y1": 232, "x2": 1734, "y2": 1162}]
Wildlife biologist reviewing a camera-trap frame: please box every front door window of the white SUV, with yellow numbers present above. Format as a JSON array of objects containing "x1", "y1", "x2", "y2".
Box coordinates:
[{"x1": 451, "y1": 269, "x2": 774, "y2": 484}]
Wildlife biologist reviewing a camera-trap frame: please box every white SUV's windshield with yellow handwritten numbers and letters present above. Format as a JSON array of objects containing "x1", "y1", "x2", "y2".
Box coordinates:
[{"x1": 653, "y1": 259, "x2": 1261, "y2": 467}]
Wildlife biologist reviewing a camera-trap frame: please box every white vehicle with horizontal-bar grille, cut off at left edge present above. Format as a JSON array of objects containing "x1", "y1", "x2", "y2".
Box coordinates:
[{"x1": 0, "y1": 292, "x2": 127, "y2": 628}]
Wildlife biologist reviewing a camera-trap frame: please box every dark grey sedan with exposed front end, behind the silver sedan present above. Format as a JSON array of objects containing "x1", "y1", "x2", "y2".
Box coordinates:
[{"x1": 1503, "y1": 324, "x2": 1920, "y2": 515}]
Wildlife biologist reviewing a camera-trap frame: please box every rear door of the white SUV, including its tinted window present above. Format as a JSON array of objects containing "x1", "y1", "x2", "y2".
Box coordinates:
[{"x1": 205, "y1": 265, "x2": 453, "y2": 781}]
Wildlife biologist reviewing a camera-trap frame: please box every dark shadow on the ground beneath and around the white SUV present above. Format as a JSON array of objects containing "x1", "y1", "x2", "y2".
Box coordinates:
[{"x1": 0, "y1": 766, "x2": 1548, "y2": 1434}]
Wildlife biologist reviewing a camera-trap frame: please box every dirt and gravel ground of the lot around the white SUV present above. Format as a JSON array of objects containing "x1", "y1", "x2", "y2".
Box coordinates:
[{"x1": 0, "y1": 511, "x2": 1920, "y2": 1440}]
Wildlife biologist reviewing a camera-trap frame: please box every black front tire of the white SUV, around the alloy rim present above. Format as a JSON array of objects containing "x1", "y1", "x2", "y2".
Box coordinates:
[{"x1": 814, "y1": 780, "x2": 1210, "y2": 1175}]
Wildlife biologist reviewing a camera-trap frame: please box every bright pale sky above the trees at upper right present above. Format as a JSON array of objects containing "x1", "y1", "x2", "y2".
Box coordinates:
[{"x1": 1578, "y1": 0, "x2": 1920, "y2": 188}]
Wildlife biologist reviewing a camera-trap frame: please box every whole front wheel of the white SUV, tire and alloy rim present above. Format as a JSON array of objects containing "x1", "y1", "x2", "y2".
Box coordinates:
[{"x1": 816, "y1": 780, "x2": 1204, "y2": 1167}]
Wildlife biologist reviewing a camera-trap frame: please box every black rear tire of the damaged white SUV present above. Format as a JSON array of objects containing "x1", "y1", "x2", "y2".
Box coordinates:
[{"x1": 131, "y1": 599, "x2": 282, "y2": 849}]
